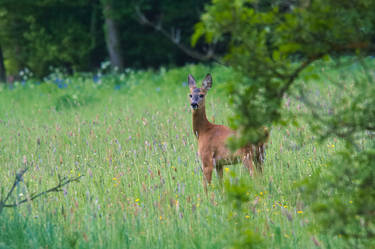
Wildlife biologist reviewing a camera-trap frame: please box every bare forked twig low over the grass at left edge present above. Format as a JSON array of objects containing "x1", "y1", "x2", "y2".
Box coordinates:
[{"x1": 0, "y1": 168, "x2": 83, "y2": 214}]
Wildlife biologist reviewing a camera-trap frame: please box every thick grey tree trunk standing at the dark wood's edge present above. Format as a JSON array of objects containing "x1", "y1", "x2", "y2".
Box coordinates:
[{"x1": 103, "y1": 1, "x2": 124, "y2": 69}]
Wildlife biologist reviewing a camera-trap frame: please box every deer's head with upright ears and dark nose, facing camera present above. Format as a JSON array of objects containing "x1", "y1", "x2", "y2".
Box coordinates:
[{"x1": 188, "y1": 74, "x2": 212, "y2": 110}]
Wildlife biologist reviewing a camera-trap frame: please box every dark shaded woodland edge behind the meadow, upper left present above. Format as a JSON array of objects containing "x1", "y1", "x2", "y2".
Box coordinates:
[{"x1": 0, "y1": 0, "x2": 209, "y2": 81}]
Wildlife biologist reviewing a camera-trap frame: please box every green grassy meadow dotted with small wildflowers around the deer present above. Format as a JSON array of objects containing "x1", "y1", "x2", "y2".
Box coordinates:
[{"x1": 0, "y1": 62, "x2": 362, "y2": 249}]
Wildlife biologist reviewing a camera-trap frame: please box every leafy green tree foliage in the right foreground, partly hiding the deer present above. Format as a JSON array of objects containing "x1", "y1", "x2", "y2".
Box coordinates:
[{"x1": 192, "y1": 0, "x2": 375, "y2": 247}]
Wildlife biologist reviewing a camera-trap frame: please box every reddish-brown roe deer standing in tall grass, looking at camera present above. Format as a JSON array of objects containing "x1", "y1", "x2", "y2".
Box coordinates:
[{"x1": 188, "y1": 74, "x2": 268, "y2": 192}]
